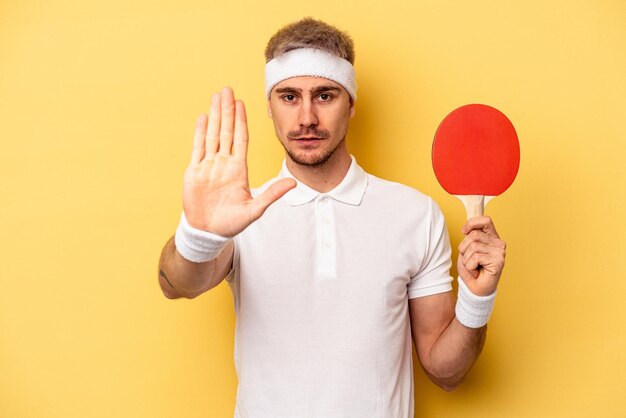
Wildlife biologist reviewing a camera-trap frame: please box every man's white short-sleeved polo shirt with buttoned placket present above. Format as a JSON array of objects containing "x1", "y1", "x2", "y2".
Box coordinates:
[{"x1": 227, "y1": 159, "x2": 452, "y2": 418}]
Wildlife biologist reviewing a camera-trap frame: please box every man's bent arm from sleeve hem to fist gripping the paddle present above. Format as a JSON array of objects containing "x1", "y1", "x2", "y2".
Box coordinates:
[{"x1": 409, "y1": 217, "x2": 506, "y2": 391}]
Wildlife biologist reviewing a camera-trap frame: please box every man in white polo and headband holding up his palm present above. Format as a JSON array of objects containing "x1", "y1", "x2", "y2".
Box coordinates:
[{"x1": 159, "y1": 19, "x2": 505, "y2": 418}]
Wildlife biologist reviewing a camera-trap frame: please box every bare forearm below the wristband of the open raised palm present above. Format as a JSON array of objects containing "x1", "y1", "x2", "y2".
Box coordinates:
[{"x1": 159, "y1": 237, "x2": 233, "y2": 299}]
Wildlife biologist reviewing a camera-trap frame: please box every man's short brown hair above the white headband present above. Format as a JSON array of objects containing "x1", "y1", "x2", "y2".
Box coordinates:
[{"x1": 265, "y1": 17, "x2": 354, "y2": 65}]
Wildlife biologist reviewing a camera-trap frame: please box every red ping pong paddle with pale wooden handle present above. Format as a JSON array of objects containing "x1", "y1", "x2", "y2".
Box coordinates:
[{"x1": 432, "y1": 104, "x2": 520, "y2": 219}]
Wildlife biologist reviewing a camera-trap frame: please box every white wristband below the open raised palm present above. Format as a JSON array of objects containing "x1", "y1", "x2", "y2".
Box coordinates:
[{"x1": 174, "y1": 212, "x2": 230, "y2": 263}]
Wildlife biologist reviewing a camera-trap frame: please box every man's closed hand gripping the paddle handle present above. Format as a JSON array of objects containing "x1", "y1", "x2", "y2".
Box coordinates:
[{"x1": 457, "y1": 216, "x2": 506, "y2": 296}]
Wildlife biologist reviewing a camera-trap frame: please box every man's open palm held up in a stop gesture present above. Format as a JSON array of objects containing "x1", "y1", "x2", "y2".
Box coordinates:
[{"x1": 183, "y1": 87, "x2": 296, "y2": 237}]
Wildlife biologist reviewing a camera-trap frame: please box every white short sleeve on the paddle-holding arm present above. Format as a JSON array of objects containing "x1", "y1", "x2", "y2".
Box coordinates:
[{"x1": 408, "y1": 198, "x2": 453, "y2": 299}]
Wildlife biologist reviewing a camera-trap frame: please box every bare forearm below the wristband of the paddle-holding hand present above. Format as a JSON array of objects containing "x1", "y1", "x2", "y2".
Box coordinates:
[{"x1": 422, "y1": 318, "x2": 487, "y2": 391}]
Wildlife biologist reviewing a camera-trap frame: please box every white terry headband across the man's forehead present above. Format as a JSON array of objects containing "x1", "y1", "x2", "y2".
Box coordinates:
[{"x1": 265, "y1": 48, "x2": 356, "y2": 100}]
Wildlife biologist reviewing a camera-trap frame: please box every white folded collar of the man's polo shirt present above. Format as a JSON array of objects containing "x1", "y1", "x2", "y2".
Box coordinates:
[{"x1": 278, "y1": 156, "x2": 367, "y2": 206}]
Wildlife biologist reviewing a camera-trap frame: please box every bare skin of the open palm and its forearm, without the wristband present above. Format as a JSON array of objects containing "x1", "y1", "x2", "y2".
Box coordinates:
[{"x1": 159, "y1": 88, "x2": 296, "y2": 298}]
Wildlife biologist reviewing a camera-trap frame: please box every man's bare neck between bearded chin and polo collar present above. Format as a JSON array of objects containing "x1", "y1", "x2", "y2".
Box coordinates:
[{"x1": 287, "y1": 142, "x2": 352, "y2": 193}]
